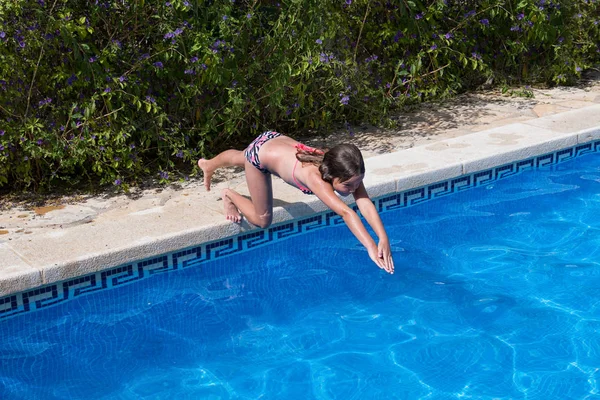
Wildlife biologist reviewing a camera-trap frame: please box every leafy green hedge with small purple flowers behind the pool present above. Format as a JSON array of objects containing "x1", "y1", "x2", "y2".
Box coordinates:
[{"x1": 0, "y1": 0, "x2": 600, "y2": 189}]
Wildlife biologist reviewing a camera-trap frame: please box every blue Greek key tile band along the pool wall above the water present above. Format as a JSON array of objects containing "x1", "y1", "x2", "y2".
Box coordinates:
[{"x1": 0, "y1": 140, "x2": 600, "y2": 320}]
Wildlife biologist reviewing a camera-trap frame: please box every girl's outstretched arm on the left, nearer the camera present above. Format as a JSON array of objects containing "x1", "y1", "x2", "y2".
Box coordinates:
[{"x1": 306, "y1": 177, "x2": 394, "y2": 273}]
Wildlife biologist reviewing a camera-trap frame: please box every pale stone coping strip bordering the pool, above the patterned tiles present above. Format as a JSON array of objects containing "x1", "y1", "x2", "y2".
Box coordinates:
[{"x1": 0, "y1": 104, "x2": 600, "y2": 296}]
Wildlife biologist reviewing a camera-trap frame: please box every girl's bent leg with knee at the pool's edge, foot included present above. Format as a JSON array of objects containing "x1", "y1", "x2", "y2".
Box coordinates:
[{"x1": 221, "y1": 162, "x2": 273, "y2": 228}]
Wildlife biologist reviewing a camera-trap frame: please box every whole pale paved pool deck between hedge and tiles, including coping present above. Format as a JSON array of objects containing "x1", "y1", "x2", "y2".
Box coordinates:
[{"x1": 0, "y1": 79, "x2": 600, "y2": 296}]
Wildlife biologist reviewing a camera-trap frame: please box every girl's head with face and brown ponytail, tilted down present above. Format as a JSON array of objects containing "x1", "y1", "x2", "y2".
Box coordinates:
[{"x1": 296, "y1": 144, "x2": 365, "y2": 196}]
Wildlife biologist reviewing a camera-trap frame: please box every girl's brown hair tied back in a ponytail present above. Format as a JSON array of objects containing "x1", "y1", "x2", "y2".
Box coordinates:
[{"x1": 296, "y1": 143, "x2": 365, "y2": 183}]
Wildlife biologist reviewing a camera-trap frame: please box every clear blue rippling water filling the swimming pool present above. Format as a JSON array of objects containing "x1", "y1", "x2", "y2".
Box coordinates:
[{"x1": 0, "y1": 155, "x2": 600, "y2": 400}]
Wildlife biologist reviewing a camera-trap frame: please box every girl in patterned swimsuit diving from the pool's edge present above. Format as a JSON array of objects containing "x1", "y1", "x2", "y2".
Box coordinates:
[{"x1": 198, "y1": 131, "x2": 394, "y2": 273}]
